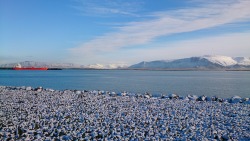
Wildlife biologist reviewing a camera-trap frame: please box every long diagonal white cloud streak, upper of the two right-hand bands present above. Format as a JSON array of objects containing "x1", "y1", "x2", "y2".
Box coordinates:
[{"x1": 71, "y1": 0, "x2": 250, "y2": 64}]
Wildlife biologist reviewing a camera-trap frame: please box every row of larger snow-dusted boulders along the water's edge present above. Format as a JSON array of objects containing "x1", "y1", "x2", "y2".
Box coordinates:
[{"x1": 0, "y1": 85, "x2": 250, "y2": 104}]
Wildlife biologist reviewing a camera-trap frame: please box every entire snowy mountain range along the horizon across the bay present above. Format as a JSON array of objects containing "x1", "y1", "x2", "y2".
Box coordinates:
[{"x1": 0, "y1": 55, "x2": 250, "y2": 70}]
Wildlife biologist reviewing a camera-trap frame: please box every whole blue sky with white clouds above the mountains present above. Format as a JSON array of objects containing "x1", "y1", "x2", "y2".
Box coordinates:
[{"x1": 0, "y1": 0, "x2": 250, "y2": 65}]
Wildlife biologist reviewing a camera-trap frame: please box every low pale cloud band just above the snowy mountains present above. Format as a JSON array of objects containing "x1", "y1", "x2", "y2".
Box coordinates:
[{"x1": 69, "y1": 31, "x2": 250, "y2": 65}]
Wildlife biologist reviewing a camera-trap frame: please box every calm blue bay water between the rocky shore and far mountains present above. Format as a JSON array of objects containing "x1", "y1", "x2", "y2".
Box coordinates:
[{"x1": 0, "y1": 70, "x2": 250, "y2": 98}]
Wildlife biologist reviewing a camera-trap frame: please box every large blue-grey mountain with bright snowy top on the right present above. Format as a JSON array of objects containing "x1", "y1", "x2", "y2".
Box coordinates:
[{"x1": 129, "y1": 55, "x2": 250, "y2": 69}]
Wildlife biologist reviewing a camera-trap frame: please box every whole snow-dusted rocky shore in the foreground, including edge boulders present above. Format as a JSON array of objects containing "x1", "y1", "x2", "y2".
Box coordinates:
[{"x1": 0, "y1": 86, "x2": 250, "y2": 141}]
